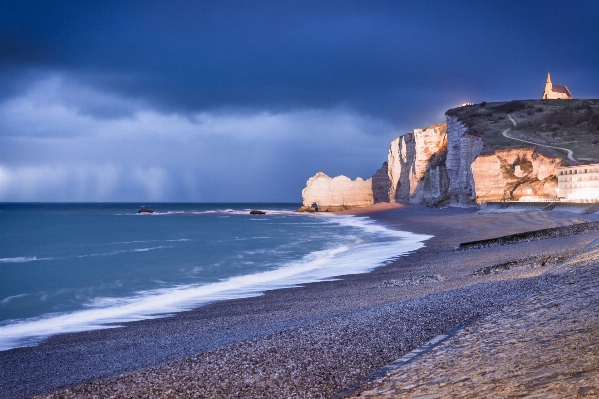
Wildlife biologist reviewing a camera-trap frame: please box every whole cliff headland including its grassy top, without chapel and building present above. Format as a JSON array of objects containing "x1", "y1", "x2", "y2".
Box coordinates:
[{"x1": 302, "y1": 100, "x2": 599, "y2": 211}]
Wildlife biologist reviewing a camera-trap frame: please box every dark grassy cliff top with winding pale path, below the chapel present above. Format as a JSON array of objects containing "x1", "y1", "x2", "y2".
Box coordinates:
[{"x1": 446, "y1": 100, "x2": 599, "y2": 164}]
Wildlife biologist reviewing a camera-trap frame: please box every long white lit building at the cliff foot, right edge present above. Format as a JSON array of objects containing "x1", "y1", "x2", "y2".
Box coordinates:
[{"x1": 557, "y1": 164, "x2": 599, "y2": 201}]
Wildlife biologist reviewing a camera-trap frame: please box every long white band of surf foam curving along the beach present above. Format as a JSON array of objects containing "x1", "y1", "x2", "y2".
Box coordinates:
[{"x1": 0, "y1": 216, "x2": 431, "y2": 350}]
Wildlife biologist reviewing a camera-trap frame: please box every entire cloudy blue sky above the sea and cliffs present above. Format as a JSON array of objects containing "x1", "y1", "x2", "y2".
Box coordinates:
[{"x1": 0, "y1": 0, "x2": 599, "y2": 203}]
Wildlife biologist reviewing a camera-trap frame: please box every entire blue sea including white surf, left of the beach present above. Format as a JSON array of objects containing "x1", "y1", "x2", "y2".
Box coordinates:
[{"x1": 0, "y1": 203, "x2": 430, "y2": 351}]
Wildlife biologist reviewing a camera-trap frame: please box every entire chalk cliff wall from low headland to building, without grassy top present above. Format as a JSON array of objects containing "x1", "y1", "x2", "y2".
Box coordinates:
[{"x1": 300, "y1": 115, "x2": 562, "y2": 211}]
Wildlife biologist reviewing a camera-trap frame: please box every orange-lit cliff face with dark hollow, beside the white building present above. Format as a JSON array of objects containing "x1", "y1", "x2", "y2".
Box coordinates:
[{"x1": 471, "y1": 148, "x2": 562, "y2": 203}]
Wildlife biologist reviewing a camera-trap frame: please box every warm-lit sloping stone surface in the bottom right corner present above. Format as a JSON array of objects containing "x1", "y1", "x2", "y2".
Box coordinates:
[{"x1": 356, "y1": 255, "x2": 599, "y2": 399}]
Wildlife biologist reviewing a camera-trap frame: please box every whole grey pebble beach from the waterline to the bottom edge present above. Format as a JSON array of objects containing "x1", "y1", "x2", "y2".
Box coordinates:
[{"x1": 0, "y1": 205, "x2": 599, "y2": 398}]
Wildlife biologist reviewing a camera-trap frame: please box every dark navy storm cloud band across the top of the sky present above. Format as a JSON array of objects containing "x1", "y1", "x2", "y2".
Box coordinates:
[{"x1": 0, "y1": 1, "x2": 599, "y2": 119}]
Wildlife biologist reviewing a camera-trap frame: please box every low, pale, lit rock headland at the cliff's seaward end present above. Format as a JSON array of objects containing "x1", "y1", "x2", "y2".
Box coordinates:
[{"x1": 299, "y1": 173, "x2": 376, "y2": 212}]
